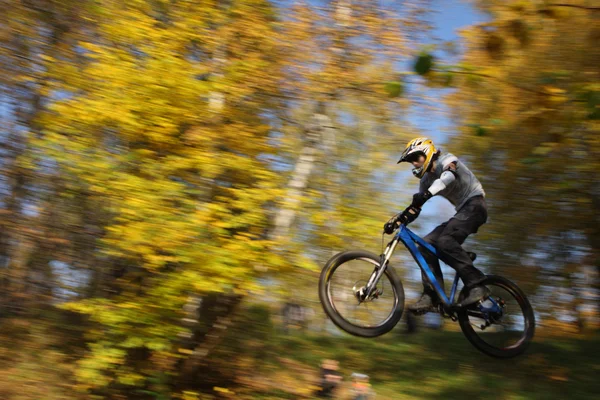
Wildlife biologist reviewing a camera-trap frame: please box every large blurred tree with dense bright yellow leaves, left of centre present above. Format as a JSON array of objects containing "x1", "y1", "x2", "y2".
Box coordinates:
[{"x1": 28, "y1": 0, "x2": 288, "y2": 392}]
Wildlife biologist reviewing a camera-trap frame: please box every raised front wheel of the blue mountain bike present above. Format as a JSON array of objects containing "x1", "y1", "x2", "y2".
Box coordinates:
[{"x1": 319, "y1": 251, "x2": 404, "y2": 337}]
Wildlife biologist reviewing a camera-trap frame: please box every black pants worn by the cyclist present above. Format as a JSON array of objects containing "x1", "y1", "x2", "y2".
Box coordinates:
[{"x1": 419, "y1": 196, "x2": 487, "y2": 294}]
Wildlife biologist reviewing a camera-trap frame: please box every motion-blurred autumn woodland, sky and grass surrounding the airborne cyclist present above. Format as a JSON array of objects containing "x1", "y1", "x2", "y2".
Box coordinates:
[{"x1": 0, "y1": 0, "x2": 600, "y2": 400}]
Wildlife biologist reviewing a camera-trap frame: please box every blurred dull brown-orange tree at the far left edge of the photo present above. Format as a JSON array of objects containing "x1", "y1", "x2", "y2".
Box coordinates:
[{"x1": 0, "y1": 0, "x2": 98, "y2": 312}]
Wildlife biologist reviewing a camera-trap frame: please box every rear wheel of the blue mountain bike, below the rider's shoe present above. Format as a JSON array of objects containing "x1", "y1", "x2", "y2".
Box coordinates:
[{"x1": 457, "y1": 275, "x2": 535, "y2": 358}]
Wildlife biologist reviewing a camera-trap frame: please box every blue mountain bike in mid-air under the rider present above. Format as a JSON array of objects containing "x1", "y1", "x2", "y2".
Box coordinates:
[{"x1": 319, "y1": 224, "x2": 535, "y2": 358}]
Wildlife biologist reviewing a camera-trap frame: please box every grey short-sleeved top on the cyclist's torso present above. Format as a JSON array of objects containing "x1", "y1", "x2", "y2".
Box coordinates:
[{"x1": 419, "y1": 153, "x2": 485, "y2": 211}]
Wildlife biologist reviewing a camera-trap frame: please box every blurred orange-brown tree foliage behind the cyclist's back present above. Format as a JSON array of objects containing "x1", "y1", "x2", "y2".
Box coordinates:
[{"x1": 440, "y1": 0, "x2": 600, "y2": 330}]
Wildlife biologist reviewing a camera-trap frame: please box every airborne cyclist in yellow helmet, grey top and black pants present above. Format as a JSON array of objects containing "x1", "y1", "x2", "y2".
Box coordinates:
[{"x1": 384, "y1": 137, "x2": 490, "y2": 314}]
